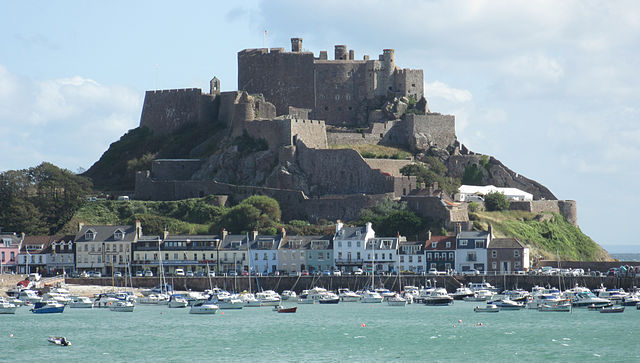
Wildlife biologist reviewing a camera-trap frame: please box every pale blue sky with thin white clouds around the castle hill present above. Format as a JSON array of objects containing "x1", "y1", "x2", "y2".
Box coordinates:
[{"x1": 0, "y1": 0, "x2": 640, "y2": 252}]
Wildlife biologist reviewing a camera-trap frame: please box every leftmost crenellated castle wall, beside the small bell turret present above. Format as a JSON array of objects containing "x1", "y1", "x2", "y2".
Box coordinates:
[{"x1": 140, "y1": 88, "x2": 218, "y2": 135}]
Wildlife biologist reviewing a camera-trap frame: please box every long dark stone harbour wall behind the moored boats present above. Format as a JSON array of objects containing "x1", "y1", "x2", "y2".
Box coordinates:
[{"x1": 66, "y1": 275, "x2": 640, "y2": 293}]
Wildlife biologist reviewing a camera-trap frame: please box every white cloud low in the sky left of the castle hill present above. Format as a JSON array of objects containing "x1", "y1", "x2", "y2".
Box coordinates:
[{"x1": 0, "y1": 65, "x2": 142, "y2": 171}]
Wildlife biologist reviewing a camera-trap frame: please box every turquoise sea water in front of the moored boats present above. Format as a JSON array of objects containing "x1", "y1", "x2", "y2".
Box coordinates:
[{"x1": 0, "y1": 301, "x2": 640, "y2": 362}]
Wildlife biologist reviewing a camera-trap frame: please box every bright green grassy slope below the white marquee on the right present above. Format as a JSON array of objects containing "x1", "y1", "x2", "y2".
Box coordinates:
[{"x1": 474, "y1": 211, "x2": 611, "y2": 261}]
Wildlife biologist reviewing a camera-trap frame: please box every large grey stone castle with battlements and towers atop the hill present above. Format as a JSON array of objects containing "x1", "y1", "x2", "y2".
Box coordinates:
[{"x1": 135, "y1": 38, "x2": 576, "y2": 230}]
